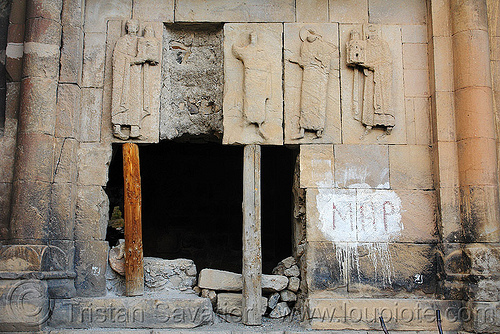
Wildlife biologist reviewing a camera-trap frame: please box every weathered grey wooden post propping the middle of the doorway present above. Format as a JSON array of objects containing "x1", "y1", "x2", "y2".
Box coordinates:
[{"x1": 242, "y1": 145, "x2": 262, "y2": 325}]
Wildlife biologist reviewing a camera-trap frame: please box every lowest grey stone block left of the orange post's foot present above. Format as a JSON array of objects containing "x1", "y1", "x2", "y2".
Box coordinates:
[{"x1": 74, "y1": 240, "x2": 109, "y2": 298}]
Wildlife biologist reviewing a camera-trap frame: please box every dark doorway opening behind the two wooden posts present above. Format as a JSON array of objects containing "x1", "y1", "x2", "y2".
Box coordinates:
[{"x1": 106, "y1": 142, "x2": 295, "y2": 273}]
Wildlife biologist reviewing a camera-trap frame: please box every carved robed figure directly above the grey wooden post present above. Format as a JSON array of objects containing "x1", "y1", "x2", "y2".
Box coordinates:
[{"x1": 232, "y1": 32, "x2": 271, "y2": 139}]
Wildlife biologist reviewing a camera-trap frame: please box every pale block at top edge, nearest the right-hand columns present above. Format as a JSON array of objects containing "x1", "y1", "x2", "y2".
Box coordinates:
[{"x1": 369, "y1": 0, "x2": 427, "y2": 24}]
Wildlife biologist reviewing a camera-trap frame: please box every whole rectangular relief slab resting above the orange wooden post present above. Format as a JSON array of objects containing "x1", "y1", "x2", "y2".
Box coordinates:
[{"x1": 104, "y1": 20, "x2": 163, "y2": 143}]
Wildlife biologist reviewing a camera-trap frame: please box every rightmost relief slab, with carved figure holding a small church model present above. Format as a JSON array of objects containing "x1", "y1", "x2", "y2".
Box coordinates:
[{"x1": 339, "y1": 24, "x2": 407, "y2": 144}]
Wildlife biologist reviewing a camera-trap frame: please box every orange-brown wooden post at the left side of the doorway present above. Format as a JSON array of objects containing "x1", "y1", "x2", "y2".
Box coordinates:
[{"x1": 123, "y1": 143, "x2": 144, "y2": 296}]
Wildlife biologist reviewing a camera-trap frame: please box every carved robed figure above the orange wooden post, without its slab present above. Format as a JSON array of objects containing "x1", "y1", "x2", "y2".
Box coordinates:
[{"x1": 111, "y1": 20, "x2": 161, "y2": 140}]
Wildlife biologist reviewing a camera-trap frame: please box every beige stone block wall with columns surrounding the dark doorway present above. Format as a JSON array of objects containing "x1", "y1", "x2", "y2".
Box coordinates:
[{"x1": 0, "y1": 0, "x2": 500, "y2": 332}]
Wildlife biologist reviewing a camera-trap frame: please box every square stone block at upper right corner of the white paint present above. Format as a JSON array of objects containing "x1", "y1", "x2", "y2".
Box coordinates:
[{"x1": 389, "y1": 145, "x2": 433, "y2": 189}]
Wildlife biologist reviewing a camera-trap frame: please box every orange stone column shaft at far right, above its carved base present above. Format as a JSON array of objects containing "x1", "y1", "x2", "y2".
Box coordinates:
[{"x1": 451, "y1": 0, "x2": 500, "y2": 242}]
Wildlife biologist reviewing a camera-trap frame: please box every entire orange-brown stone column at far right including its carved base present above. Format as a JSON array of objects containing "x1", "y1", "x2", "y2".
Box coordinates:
[{"x1": 451, "y1": 0, "x2": 500, "y2": 333}]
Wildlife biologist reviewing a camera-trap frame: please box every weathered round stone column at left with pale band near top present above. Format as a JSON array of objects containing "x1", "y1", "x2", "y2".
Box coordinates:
[{"x1": 10, "y1": 0, "x2": 62, "y2": 244}]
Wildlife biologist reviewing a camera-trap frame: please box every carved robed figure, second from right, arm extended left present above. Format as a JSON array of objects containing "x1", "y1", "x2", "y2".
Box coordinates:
[{"x1": 289, "y1": 27, "x2": 336, "y2": 139}]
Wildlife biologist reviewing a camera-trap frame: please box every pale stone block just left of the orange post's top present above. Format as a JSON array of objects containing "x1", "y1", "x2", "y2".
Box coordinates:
[{"x1": 78, "y1": 143, "x2": 111, "y2": 186}]
